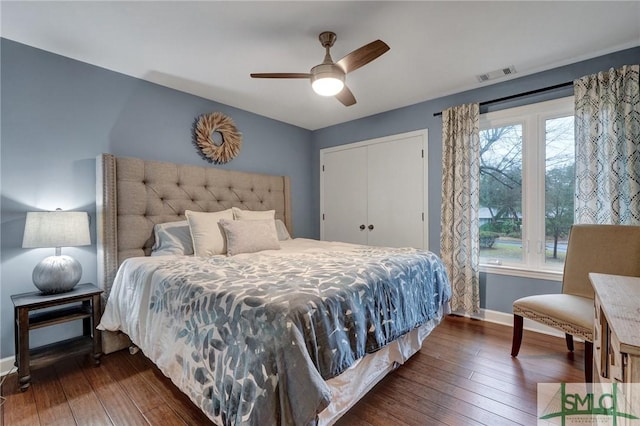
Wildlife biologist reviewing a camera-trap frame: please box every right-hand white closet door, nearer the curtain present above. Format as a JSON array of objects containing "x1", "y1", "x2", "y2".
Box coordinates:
[{"x1": 367, "y1": 136, "x2": 426, "y2": 248}]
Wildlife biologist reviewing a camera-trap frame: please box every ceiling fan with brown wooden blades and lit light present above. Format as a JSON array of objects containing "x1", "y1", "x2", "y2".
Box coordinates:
[{"x1": 251, "y1": 31, "x2": 389, "y2": 106}]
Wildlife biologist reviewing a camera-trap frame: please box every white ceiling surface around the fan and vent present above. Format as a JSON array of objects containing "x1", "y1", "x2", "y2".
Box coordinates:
[{"x1": 1, "y1": 1, "x2": 640, "y2": 130}]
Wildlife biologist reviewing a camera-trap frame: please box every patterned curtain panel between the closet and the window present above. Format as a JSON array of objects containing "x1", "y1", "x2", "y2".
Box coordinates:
[{"x1": 440, "y1": 104, "x2": 480, "y2": 315}]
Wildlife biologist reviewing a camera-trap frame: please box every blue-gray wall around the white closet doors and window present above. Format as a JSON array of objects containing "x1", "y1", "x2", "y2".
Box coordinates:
[{"x1": 311, "y1": 47, "x2": 640, "y2": 313}]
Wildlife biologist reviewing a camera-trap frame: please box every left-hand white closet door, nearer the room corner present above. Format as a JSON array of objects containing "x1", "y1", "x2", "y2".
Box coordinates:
[{"x1": 321, "y1": 148, "x2": 367, "y2": 244}]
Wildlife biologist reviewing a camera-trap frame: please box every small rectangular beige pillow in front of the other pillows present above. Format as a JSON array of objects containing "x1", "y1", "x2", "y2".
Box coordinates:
[{"x1": 220, "y1": 219, "x2": 280, "y2": 256}]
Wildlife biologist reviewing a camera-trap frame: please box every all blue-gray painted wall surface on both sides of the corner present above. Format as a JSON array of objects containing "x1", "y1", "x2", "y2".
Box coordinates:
[{"x1": 0, "y1": 39, "x2": 640, "y2": 357}]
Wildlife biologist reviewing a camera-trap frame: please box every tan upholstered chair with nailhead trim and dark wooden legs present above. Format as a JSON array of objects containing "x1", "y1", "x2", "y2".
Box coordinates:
[{"x1": 511, "y1": 225, "x2": 640, "y2": 383}]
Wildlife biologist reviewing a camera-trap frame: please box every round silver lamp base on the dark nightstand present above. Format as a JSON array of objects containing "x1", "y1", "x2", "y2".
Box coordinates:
[{"x1": 33, "y1": 255, "x2": 82, "y2": 294}]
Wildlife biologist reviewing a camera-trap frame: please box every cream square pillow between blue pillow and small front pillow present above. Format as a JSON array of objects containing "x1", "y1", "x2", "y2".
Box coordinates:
[{"x1": 184, "y1": 209, "x2": 233, "y2": 257}]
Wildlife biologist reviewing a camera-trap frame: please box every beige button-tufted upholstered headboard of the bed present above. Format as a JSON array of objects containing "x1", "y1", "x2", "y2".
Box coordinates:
[{"x1": 96, "y1": 154, "x2": 293, "y2": 353}]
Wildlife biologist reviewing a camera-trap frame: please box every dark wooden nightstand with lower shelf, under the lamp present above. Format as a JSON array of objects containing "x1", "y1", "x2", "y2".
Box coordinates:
[{"x1": 11, "y1": 284, "x2": 102, "y2": 391}]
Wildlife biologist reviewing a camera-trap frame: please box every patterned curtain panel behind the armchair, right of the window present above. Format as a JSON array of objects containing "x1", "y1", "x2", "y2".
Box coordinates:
[{"x1": 573, "y1": 65, "x2": 640, "y2": 225}]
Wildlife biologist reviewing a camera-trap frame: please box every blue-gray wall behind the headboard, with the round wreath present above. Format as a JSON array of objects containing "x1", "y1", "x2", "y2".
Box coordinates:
[{"x1": 0, "y1": 39, "x2": 316, "y2": 357}]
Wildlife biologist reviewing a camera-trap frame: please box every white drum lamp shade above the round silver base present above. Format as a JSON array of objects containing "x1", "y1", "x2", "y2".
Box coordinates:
[{"x1": 22, "y1": 211, "x2": 91, "y2": 248}]
